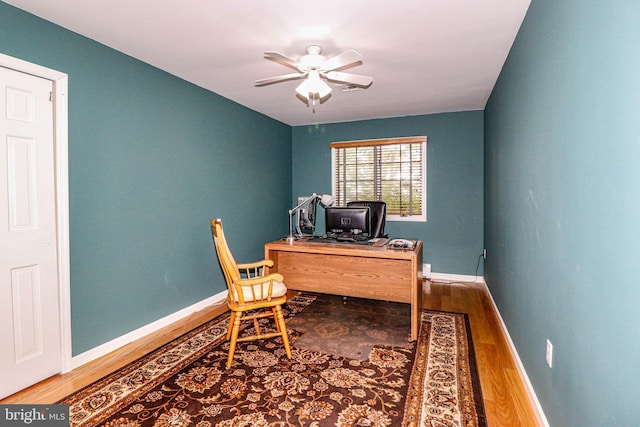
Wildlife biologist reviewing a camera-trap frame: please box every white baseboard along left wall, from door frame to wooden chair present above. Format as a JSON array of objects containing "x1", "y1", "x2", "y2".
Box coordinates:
[{"x1": 70, "y1": 291, "x2": 227, "y2": 372}]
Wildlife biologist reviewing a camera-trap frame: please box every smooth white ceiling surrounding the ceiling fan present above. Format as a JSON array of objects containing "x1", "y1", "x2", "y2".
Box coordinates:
[{"x1": 5, "y1": 0, "x2": 530, "y2": 126}]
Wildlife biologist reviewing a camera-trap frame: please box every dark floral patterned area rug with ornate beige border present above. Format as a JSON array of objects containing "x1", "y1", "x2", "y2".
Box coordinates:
[{"x1": 59, "y1": 294, "x2": 486, "y2": 427}]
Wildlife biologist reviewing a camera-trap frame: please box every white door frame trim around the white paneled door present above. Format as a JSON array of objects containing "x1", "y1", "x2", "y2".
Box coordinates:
[{"x1": 0, "y1": 53, "x2": 72, "y2": 373}]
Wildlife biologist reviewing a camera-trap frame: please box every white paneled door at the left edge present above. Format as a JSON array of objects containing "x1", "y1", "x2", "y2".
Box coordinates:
[{"x1": 0, "y1": 67, "x2": 62, "y2": 398}]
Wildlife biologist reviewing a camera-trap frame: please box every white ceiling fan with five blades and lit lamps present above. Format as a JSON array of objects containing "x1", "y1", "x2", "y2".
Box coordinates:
[{"x1": 255, "y1": 45, "x2": 373, "y2": 106}]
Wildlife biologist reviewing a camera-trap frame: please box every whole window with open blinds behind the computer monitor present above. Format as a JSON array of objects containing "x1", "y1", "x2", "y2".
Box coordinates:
[{"x1": 329, "y1": 136, "x2": 427, "y2": 221}]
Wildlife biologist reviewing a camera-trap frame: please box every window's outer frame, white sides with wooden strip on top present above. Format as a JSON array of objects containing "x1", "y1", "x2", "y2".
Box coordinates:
[{"x1": 329, "y1": 136, "x2": 427, "y2": 222}]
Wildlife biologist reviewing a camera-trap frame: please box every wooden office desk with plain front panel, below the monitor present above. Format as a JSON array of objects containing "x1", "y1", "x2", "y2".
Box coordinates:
[{"x1": 264, "y1": 238, "x2": 422, "y2": 341}]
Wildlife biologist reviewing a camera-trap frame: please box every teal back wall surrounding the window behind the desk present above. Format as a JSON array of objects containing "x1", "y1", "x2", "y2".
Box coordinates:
[{"x1": 292, "y1": 111, "x2": 484, "y2": 275}]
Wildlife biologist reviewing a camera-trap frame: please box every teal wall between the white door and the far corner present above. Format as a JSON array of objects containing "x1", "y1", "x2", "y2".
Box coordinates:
[{"x1": 0, "y1": 2, "x2": 291, "y2": 355}]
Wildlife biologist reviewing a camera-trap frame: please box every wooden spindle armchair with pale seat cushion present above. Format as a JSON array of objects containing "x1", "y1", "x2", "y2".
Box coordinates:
[{"x1": 211, "y1": 219, "x2": 291, "y2": 368}]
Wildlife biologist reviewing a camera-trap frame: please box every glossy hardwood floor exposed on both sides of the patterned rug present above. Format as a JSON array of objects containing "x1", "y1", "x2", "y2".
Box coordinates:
[{"x1": 0, "y1": 282, "x2": 542, "y2": 427}]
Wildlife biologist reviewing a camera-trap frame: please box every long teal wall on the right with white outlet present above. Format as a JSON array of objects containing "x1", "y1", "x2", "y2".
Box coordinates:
[{"x1": 485, "y1": 0, "x2": 640, "y2": 427}]
